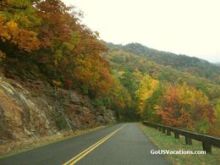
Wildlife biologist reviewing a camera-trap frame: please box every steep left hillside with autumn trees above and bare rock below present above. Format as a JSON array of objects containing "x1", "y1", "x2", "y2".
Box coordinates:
[{"x1": 0, "y1": 0, "x2": 118, "y2": 151}]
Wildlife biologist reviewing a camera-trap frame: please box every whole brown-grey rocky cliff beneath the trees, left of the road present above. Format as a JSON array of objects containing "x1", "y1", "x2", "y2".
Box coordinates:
[{"x1": 0, "y1": 77, "x2": 115, "y2": 144}]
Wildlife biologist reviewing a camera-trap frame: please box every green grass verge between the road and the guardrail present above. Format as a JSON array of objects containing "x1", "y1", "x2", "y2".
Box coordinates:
[{"x1": 140, "y1": 124, "x2": 220, "y2": 165}]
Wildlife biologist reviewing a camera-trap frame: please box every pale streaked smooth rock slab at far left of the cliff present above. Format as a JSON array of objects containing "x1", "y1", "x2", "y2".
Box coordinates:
[{"x1": 0, "y1": 78, "x2": 54, "y2": 139}]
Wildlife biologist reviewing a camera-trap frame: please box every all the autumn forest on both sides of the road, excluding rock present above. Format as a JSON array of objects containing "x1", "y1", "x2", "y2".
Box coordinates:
[{"x1": 0, "y1": 0, "x2": 220, "y2": 136}]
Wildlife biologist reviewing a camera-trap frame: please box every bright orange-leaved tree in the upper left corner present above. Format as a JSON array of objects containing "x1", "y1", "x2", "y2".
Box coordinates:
[{"x1": 0, "y1": 0, "x2": 40, "y2": 56}]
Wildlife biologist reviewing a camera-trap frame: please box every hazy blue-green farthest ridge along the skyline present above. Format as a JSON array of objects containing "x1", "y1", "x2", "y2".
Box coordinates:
[{"x1": 109, "y1": 43, "x2": 220, "y2": 83}]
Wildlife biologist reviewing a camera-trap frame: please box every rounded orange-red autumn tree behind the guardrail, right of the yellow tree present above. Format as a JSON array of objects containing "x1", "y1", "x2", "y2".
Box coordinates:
[{"x1": 157, "y1": 84, "x2": 214, "y2": 133}]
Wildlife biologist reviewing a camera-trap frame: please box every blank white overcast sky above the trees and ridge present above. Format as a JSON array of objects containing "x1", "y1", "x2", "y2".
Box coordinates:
[{"x1": 63, "y1": 0, "x2": 220, "y2": 62}]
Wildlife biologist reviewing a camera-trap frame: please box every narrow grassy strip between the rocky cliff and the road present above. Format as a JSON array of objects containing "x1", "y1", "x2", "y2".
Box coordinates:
[{"x1": 0, "y1": 125, "x2": 106, "y2": 159}]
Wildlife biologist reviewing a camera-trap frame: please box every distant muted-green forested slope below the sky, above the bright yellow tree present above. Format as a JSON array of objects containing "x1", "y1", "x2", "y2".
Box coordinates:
[{"x1": 104, "y1": 44, "x2": 220, "y2": 98}]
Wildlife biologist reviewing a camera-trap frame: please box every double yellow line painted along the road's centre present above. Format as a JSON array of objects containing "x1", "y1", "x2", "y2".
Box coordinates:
[{"x1": 63, "y1": 125, "x2": 125, "y2": 165}]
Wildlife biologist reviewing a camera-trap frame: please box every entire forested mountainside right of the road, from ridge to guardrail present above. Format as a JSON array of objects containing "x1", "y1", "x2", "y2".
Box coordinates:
[{"x1": 103, "y1": 43, "x2": 220, "y2": 134}]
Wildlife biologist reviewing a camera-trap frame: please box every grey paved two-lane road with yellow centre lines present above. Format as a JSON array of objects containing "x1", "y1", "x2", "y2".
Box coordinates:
[{"x1": 0, "y1": 123, "x2": 170, "y2": 165}]
